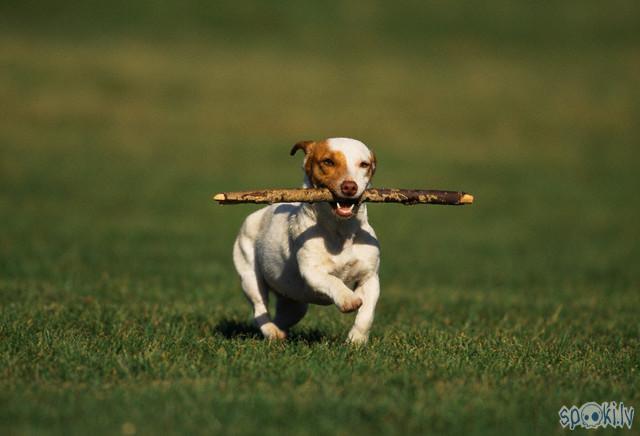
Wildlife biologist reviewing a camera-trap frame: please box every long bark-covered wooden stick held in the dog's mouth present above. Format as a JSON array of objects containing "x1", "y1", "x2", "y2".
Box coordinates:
[{"x1": 213, "y1": 188, "x2": 473, "y2": 206}]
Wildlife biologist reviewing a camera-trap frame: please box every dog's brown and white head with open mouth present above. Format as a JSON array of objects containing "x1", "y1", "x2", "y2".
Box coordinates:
[{"x1": 291, "y1": 138, "x2": 376, "y2": 218}]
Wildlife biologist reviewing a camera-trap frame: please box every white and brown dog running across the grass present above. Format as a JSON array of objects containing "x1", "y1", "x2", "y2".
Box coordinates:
[{"x1": 233, "y1": 138, "x2": 380, "y2": 343}]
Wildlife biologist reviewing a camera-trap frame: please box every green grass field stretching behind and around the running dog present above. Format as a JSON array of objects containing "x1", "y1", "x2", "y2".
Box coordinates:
[{"x1": 0, "y1": 0, "x2": 640, "y2": 435}]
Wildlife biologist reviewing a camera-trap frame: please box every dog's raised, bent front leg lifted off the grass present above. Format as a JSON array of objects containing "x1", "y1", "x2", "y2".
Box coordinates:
[{"x1": 300, "y1": 263, "x2": 362, "y2": 313}]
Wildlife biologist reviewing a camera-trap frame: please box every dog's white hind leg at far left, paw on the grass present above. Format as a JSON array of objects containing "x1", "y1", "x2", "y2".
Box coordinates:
[{"x1": 233, "y1": 234, "x2": 286, "y2": 339}]
